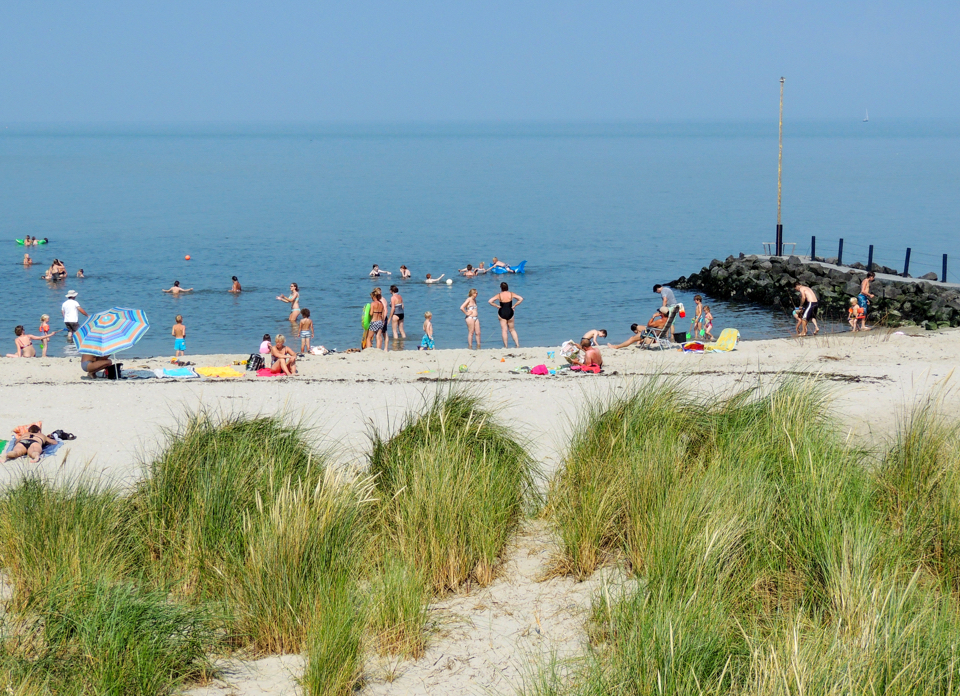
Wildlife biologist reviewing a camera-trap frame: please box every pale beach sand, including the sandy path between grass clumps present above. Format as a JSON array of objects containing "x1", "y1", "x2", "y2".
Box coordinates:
[{"x1": 0, "y1": 330, "x2": 960, "y2": 695}]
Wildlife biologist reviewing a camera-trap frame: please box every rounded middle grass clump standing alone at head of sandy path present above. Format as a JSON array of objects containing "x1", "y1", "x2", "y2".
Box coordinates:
[{"x1": 370, "y1": 391, "x2": 535, "y2": 593}]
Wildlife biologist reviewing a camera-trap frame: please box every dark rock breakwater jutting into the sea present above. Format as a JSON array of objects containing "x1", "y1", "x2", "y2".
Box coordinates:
[{"x1": 668, "y1": 254, "x2": 960, "y2": 329}]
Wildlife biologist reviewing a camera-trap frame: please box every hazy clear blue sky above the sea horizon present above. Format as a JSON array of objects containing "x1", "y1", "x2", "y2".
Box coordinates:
[{"x1": 0, "y1": 0, "x2": 960, "y2": 123}]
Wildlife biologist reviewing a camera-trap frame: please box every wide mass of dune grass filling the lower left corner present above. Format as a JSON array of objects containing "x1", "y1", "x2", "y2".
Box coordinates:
[{"x1": 0, "y1": 413, "x2": 373, "y2": 694}]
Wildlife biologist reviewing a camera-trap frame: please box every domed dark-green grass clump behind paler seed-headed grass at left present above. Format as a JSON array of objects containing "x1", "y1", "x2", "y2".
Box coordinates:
[{"x1": 133, "y1": 412, "x2": 325, "y2": 600}]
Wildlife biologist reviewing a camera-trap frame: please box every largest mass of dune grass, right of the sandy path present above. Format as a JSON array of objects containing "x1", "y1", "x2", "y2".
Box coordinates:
[{"x1": 545, "y1": 379, "x2": 960, "y2": 696}]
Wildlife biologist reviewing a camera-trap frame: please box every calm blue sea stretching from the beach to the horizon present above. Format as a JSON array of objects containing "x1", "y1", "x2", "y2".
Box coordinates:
[{"x1": 0, "y1": 118, "x2": 960, "y2": 357}]
